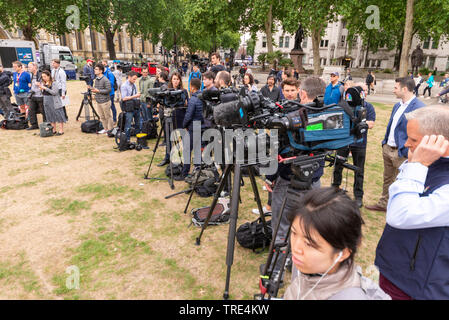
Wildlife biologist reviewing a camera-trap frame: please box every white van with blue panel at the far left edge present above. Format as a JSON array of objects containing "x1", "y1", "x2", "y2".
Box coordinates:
[{"x1": 0, "y1": 39, "x2": 37, "y2": 72}]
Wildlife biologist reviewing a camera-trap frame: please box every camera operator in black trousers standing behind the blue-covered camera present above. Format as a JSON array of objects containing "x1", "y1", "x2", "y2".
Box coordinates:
[{"x1": 332, "y1": 81, "x2": 376, "y2": 208}]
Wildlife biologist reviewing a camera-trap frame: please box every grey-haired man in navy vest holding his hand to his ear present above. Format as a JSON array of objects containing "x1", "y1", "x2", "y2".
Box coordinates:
[{"x1": 375, "y1": 105, "x2": 449, "y2": 300}]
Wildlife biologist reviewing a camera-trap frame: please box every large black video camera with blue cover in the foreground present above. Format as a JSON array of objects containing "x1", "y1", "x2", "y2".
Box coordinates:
[{"x1": 203, "y1": 87, "x2": 368, "y2": 155}]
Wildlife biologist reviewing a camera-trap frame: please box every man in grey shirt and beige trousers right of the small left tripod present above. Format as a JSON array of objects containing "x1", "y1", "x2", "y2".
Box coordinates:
[{"x1": 87, "y1": 63, "x2": 114, "y2": 134}]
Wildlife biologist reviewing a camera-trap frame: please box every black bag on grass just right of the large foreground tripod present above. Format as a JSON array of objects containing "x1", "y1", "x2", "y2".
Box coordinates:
[{"x1": 236, "y1": 217, "x2": 272, "y2": 253}]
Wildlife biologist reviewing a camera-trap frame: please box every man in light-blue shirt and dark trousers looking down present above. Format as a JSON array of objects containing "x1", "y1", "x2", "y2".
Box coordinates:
[{"x1": 120, "y1": 71, "x2": 140, "y2": 141}]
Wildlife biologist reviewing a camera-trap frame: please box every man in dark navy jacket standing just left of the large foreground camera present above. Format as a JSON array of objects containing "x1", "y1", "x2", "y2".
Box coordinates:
[{"x1": 179, "y1": 78, "x2": 204, "y2": 180}]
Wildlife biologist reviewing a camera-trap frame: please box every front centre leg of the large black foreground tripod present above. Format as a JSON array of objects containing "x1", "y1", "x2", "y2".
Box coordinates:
[{"x1": 223, "y1": 165, "x2": 241, "y2": 300}]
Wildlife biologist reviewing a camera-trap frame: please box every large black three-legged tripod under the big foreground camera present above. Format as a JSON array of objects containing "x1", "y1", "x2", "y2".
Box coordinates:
[{"x1": 196, "y1": 164, "x2": 269, "y2": 300}]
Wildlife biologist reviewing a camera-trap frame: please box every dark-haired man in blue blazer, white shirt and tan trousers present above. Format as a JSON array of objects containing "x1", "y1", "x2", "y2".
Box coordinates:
[{"x1": 365, "y1": 77, "x2": 425, "y2": 212}]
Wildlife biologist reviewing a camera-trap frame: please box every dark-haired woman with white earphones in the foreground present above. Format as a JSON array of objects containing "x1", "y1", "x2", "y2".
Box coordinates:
[{"x1": 284, "y1": 187, "x2": 391, "y2": 300}]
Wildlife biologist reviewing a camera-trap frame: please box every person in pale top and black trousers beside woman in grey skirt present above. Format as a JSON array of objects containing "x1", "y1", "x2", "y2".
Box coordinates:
[{"x1": 27, "y1": 62, "x2": 46, "y2": 130}]
